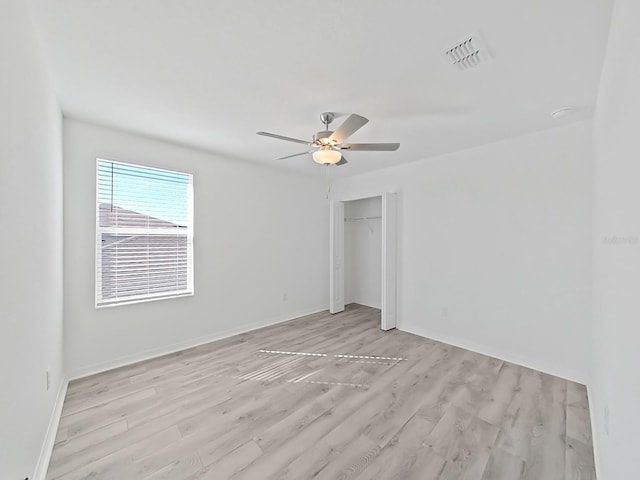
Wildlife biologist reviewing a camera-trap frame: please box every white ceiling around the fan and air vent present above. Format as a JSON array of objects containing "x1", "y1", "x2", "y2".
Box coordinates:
[{"x1": 32, "y1": 0, "x2": 612, "y2": 176}]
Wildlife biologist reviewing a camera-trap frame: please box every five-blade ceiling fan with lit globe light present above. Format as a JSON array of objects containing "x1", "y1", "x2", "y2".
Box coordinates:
[{"x1": 257, "y1": 112, "x2": 400, "y2": 165}]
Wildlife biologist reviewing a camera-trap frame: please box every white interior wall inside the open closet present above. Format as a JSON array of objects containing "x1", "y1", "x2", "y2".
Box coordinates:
[{"x1": 344, "y1": 197, "x2": 382, "y2": 308}]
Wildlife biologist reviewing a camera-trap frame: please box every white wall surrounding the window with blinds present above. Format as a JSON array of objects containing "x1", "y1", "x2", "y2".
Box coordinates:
[{"x1": 64, "y1": 120, "x2": 329, "y2": 377}]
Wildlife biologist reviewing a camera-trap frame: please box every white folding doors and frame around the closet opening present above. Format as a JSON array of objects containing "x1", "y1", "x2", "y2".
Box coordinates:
[{"x1": 329, "y1": 192, "x2": 398, "y2": 330}]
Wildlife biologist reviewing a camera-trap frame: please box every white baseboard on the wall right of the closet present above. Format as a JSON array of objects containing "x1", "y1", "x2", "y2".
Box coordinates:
[{"x1": 398, "y1": 324, "x2": 587, "y2": 384}]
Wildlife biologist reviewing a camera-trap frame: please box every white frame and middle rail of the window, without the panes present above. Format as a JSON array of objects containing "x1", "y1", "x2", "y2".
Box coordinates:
[{"x1": 94, "y1": 157, "x2": 195, "y2": 309}]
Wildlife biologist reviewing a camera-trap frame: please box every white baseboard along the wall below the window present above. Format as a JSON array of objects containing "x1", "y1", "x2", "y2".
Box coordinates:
[{"x1": 67, "y1": 306, "x2": 327, "y2": 381}]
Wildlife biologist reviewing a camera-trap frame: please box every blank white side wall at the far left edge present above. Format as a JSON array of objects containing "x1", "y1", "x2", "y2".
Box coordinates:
[{"x1": 0, "y1": 0, "x2": 65, "y2": 480}]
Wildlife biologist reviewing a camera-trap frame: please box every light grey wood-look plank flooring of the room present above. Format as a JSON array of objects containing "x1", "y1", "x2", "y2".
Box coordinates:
[{"x1": 47, "y1": 305, "x2": 595, "y2": 480}]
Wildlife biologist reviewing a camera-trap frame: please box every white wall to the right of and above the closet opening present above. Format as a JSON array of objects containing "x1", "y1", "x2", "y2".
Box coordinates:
[{"x1": 332, "y1": 121, "x2": 593, "y2": 382}]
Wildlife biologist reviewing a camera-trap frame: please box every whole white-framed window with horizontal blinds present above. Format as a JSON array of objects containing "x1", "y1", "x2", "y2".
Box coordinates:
[{"x1": 96, "y1": 159, "x2": 193, "y2": 307}]
